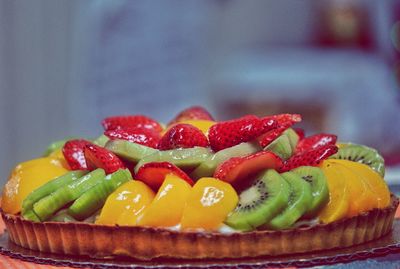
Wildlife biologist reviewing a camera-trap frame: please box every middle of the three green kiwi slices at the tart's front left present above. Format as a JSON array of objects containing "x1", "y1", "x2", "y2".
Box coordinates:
[{"x1": 33, "y1": 168, "x2": 106, "y2": 221}]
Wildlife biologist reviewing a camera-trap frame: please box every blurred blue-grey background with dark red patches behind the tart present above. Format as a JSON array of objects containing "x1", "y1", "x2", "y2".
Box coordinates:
[{"x1": 0, "y1": 0, "x2": 400, "y2": 183}]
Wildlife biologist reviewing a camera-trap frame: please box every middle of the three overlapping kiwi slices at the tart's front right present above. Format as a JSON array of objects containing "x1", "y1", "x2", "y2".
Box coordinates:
[{"x1": 263, "y1": 172, "x2": 313, "y2": 230}]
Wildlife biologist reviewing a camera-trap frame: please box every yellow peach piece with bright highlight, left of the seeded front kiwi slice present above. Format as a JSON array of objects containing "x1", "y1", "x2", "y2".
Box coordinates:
[{"x1": 181, "y1": 177, "x2": 238, "y2": 230}]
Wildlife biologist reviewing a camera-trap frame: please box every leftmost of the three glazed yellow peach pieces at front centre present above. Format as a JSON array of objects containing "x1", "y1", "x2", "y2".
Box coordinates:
[{"x1": 96, "y1": 180, "x2": 155, "y2": 225}]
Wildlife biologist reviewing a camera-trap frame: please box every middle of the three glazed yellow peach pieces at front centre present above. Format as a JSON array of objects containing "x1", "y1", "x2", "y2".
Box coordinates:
[{"x1": 137, "y1": 174, "x2": 191, "y2": 227}]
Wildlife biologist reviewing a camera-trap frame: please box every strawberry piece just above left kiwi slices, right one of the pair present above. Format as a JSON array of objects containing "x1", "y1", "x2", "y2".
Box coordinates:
[{"x1": 84, "y1": 144, "x2": 125, "y2": 174}]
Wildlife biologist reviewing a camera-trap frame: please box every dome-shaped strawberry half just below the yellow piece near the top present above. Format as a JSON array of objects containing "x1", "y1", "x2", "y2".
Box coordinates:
[{"x1": 158, "y1": 123, "x2": 208, "y2": 150}]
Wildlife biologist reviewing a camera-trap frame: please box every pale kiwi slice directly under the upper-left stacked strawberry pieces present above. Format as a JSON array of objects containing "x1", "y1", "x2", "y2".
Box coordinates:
[{"x1": 105, "y1": 139, "x2": 159, "y2": 163}]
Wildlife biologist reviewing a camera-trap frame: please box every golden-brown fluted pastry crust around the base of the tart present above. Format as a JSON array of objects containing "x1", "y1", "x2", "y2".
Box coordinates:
[{"x1": 2, "y1": 195, "x2": 399, "y2": 260}]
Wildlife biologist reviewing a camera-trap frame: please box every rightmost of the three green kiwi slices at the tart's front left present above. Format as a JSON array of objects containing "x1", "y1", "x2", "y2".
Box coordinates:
[{"x1": 68, "y1": 169, "x2": 132, "y2": 220}]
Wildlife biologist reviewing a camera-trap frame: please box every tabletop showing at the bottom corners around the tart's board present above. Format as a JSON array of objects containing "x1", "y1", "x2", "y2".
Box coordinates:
[{"x1": 0, "y1": 202, "x2": 400, "y2": 269}]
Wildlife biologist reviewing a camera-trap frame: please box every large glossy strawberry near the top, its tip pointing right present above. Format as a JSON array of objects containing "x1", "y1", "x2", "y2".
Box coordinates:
[{"x1": 208, "y1": 115, "x2": 276, "y2": 151}]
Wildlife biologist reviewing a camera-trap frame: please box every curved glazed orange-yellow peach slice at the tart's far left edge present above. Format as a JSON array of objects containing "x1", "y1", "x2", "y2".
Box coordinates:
[{"x1": 2, "y1": 157, "x2": 68, "y2": 214}]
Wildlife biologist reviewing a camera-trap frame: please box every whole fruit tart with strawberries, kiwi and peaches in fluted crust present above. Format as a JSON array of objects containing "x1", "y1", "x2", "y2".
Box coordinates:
[{"x1": 2, "y1": 106, "x2": 398, "y2": 260}]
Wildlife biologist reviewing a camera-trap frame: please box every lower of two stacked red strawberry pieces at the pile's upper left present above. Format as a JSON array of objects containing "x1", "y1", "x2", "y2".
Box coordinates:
[{"x1": 104, "y1": 128, "x2": 161, "y2": 148}]
